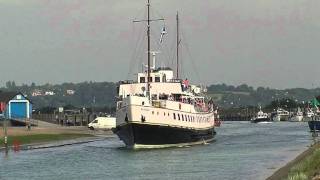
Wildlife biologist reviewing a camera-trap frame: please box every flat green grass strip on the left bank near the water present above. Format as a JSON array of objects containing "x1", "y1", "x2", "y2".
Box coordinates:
[{"x1": 0, "y1": 134, "x2": 92, "y2": 147}]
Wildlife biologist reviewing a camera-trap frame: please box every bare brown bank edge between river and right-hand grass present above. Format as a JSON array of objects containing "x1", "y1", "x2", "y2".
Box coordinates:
[{"x1": 266, "y1": 141, "x2": 320, "y2": 180}]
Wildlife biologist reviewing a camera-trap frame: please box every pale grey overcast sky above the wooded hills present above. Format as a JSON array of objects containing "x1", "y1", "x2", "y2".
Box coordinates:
[{"x1": 0, "y1": 0, "x2": 320, "y2": 88}]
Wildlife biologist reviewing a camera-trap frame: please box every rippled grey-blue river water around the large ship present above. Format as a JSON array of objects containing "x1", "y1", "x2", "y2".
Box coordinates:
[{"x1": 0, "y1": 122, "x2": 312, "y2": 180}]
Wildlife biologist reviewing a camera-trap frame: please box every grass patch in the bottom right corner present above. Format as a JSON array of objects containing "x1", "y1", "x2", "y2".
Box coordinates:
[{"x1": 288, "y1": 147, "x2": 320, "y2": 180}]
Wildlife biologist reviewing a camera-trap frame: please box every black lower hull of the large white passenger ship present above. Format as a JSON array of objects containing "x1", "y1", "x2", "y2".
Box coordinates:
[{"x1": 112, "y1": 123, "x2": 216, "y2": 148}]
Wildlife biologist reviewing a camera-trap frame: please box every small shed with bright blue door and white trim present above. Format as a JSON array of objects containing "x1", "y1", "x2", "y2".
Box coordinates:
[{"x1": 0, "y1": 92, "x2": 32, "y2": 119}]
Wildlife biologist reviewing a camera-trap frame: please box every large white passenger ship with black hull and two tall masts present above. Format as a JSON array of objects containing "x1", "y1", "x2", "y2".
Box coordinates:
[{"x1": 113, "y1": 0, "x2": 216, "y2": 149}]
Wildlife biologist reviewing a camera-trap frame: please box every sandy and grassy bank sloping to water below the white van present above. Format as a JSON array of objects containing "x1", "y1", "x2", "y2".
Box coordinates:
[{"x1": 0, "y1": 127, "x2": 113, "y2": 152}]
